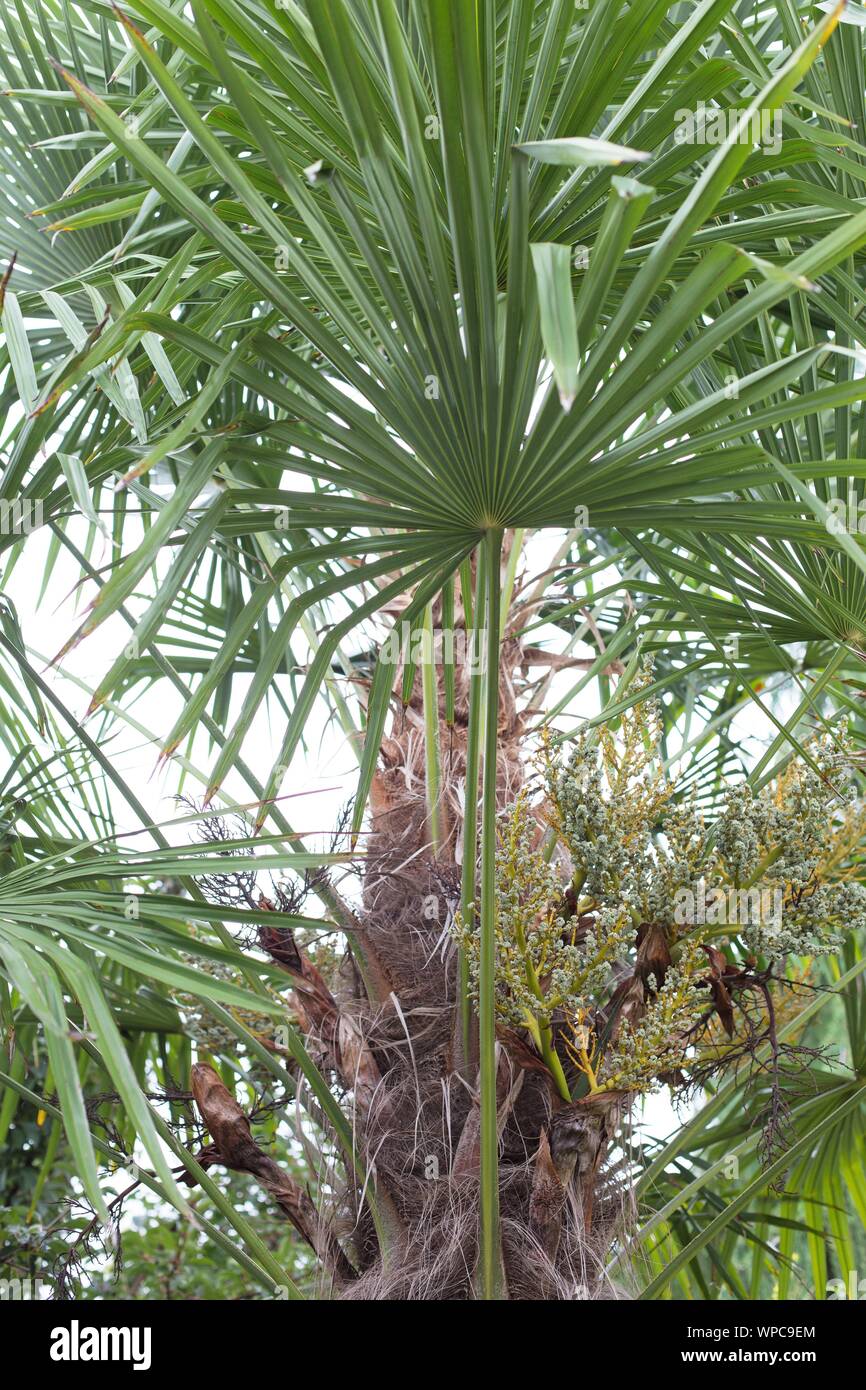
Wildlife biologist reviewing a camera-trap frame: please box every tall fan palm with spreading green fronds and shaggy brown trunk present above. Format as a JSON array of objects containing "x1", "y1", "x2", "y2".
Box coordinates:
[{"x1": 0, "y1": 0, "x2": 866, "y2": 1298}]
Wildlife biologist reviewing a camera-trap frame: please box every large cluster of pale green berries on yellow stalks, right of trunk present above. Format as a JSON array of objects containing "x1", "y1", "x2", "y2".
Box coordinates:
[{"x1": 453, "y1": 664, "x2": 866, "y2": 1098}]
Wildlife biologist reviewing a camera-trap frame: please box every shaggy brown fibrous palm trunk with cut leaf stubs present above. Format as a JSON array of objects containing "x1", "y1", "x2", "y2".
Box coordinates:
[{"x1": 196, "y1": 539, "x2": 636, "y2": 1300}]
